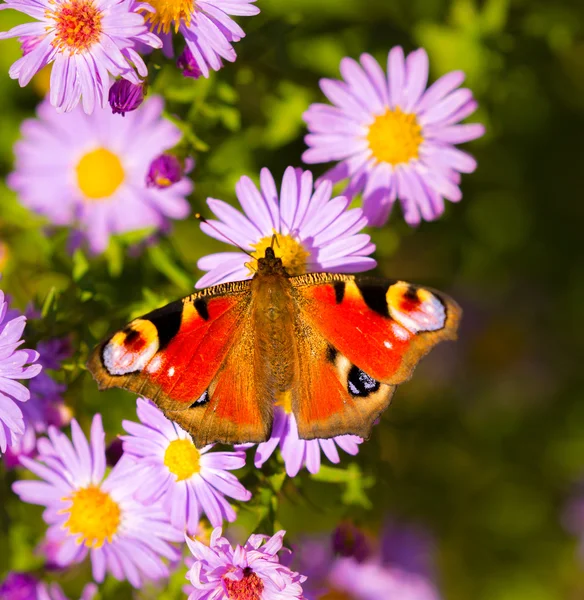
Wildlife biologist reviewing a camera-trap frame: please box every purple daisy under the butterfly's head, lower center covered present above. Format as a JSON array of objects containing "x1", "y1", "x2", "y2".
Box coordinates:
[{"x1": 197, "y1": 167, "x2": 376, "y2": 288}]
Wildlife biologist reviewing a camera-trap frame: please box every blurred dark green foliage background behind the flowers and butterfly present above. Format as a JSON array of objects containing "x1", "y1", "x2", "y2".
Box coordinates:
[{"x1": 0, "y1": 0, "x2": 584, "y2": 600}]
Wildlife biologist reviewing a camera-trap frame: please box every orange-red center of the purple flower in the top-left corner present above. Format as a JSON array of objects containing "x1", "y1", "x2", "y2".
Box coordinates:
[{"x1": 50, "y1": 0, "x2": 103, "y2": 54}]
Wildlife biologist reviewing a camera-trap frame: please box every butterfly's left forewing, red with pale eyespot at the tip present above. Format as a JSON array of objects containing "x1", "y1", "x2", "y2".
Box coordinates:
[{"x1": 88, "y1": 281, "x2": 250, "y2": 411}]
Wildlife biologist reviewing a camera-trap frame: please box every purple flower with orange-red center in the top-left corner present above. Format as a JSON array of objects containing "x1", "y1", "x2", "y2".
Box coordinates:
[{"x1": 0, "y1": 0, "x2": 161, "y2": 114}]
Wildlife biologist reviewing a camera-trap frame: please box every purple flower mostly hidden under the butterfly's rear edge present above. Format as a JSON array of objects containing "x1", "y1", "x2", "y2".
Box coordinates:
[{"x1": 246, "y1": 407, "x2": 363, "y2": 477}]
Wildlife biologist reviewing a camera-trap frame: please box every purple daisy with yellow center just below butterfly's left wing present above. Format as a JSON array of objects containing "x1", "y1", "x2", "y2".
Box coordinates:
[{"x1": 122, "y1": 398, "x2": 251, "y2": 533}]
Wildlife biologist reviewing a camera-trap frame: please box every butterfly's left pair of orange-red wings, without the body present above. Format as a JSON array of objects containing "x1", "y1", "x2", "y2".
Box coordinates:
[{"x1": 87, "y1": 281, "x2": 272, "y2": 447}]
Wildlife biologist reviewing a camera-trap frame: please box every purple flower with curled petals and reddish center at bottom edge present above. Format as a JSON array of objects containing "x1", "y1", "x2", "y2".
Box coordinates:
[{"x1": 187, "y1": 528, "x2": 306, "y2": 600}]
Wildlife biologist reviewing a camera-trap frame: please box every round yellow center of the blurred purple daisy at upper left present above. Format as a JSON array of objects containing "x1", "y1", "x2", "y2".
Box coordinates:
[{"x1": 76, "y1": 148, "x2": 125, "y2": 200}]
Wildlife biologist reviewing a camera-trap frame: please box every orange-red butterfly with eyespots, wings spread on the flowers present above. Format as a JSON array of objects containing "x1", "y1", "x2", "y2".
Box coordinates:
[{"x1": 87, "y1": 247, "x2": 461, "y2": 447}]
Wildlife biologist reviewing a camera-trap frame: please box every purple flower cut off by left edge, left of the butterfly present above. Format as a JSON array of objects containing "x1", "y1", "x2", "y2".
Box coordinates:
[{"x1": 0, "y1": 290, "x2": 42, "y2": 453}]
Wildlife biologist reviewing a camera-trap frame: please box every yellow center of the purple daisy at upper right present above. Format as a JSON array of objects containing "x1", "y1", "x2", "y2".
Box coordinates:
[{"x1": 367, "y1": 107, "x2": 424, "y2": 165}]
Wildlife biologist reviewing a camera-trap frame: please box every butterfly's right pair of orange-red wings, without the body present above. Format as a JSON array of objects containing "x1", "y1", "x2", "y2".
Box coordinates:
[{"x1": 292, "y1": 273, "x2": 461, "y2": 439}]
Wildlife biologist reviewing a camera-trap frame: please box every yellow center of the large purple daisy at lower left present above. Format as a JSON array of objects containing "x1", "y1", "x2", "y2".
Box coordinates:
[{"x1": 61, "y1": 485, "x2": 121, "y2": 548}]
